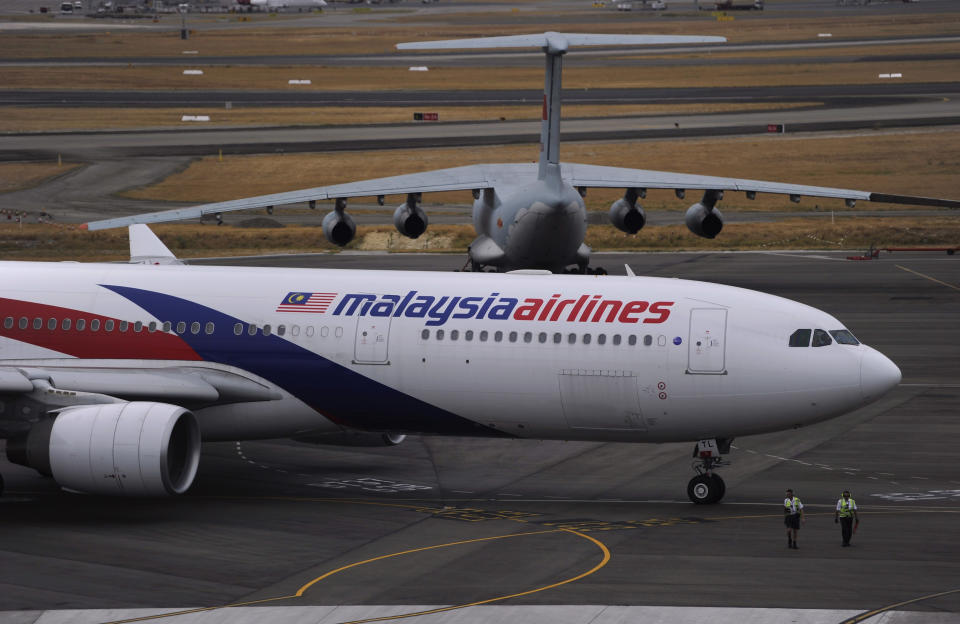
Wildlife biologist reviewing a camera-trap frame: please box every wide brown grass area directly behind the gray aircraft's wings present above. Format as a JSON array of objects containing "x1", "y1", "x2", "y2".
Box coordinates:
[{"x1": 125, "y1": 128, "x2": 960, "y2": 211}]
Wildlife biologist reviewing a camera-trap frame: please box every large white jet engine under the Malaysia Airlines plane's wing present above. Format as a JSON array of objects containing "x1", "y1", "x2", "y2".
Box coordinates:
[{"x1": 7, "y1": 401, "x2": 200, "y2": 496}]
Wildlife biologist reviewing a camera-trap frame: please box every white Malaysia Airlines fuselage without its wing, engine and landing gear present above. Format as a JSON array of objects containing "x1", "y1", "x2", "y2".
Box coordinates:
[{"x1": 0, "y1": 263, "x2": 900, "y2": 442}]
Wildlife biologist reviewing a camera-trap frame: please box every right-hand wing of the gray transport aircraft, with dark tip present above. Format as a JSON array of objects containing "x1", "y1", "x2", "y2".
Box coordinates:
[{"x1": 561, "y1": 163, "x2": 960, "y2": 208}]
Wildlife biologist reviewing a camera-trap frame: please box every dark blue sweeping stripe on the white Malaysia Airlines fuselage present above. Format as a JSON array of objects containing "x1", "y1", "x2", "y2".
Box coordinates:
[{"x1": 102, "y1": 284, "x2": 508, "y2": 436}]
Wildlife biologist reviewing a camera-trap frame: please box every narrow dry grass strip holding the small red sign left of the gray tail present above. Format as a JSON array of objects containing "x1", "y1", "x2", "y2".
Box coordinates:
[{"x1": 0, "y1": 102, "x2": 818, "y2": 132}]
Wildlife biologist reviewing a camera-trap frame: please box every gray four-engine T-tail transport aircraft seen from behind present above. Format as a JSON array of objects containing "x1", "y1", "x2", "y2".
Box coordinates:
[{"x1": 85, "y1": 32, "x2": 960, "y2": 273}]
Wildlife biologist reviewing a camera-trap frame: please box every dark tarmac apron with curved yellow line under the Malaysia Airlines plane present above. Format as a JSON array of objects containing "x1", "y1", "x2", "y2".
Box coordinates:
[{"x1": 0, "y1": 252, "x2": 960, "y2": 623}]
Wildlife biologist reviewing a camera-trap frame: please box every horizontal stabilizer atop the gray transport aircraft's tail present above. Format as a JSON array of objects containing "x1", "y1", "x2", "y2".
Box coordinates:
[{"x1": 397, "y1": 32, "x2": 727, "y2": 50}]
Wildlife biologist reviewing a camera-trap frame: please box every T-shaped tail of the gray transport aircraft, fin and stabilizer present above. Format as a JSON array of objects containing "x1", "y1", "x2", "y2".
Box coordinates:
[{"x1": 397, "y1": 32, "x2": 726, "y2": 179}]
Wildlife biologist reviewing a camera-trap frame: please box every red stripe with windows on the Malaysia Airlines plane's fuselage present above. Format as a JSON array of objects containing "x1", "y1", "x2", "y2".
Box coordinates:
[{"x1": 0, "y1": 297, "x2": 203, "y2": 360}]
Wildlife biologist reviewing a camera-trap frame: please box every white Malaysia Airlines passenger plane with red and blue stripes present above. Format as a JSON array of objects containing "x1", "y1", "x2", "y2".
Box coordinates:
[{"x1": 0, "y1": 225, "x2": 900, "y2": 503}]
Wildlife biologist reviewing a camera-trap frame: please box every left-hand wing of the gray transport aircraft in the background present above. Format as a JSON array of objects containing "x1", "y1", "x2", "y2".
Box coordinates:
[{"x1": 82, "y1": 164, "x2": 536, "y2": 230}]
